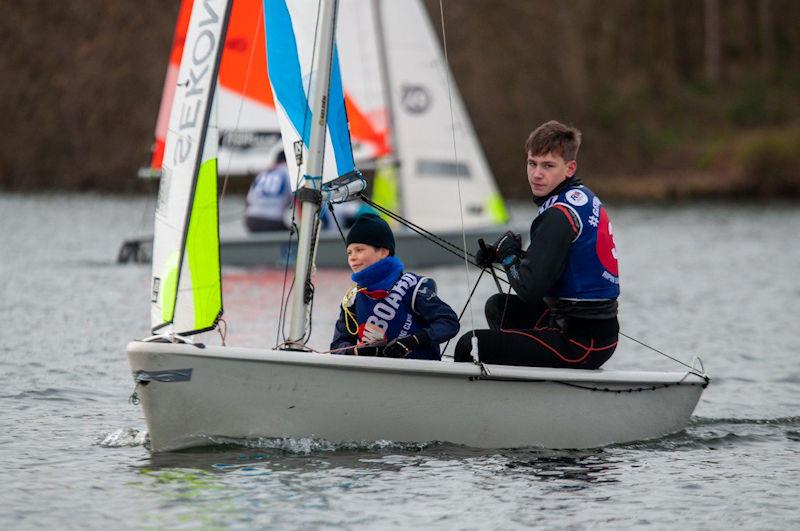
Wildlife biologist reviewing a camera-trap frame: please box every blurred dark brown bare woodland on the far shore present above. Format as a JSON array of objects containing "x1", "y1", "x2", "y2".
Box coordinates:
[{"x1": 0, "y1": 0, "x2": 800, "y2": 194}]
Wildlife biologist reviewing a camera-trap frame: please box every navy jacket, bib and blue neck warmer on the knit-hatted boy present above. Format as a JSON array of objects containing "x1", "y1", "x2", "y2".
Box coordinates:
[{"x1": 331, "y1": 257, "x2": 459, "y2": 360}]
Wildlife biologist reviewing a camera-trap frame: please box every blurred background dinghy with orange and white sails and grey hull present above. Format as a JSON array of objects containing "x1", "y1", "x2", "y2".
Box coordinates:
[{"x1": 118, "y1": 0, "x2": 512, "y2": 268}]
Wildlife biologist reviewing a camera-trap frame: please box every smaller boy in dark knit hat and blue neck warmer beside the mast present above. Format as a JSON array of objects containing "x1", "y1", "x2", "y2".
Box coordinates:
[{"x1": 331, "y1": 214, "x2": 459, "y2": 360}]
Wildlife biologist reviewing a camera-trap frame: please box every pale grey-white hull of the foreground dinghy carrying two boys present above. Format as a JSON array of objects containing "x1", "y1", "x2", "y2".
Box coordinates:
[{"x1": 128, "y1": 342, "x2": 706, "y2": 452}]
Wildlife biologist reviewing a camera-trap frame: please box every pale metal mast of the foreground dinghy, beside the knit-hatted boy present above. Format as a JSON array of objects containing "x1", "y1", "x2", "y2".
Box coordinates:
[{"x1": 287, "y1": 0, "x2": 339, "y2": 347}]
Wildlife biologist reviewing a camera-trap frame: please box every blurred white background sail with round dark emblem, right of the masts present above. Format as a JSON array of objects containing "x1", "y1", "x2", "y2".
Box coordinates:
[{"x1": 380, "y1": 0, "x2": 508, "y2": 231}]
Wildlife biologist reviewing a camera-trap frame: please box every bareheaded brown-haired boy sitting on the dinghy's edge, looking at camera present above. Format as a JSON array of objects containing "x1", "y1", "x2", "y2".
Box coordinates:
[{"x1": 455, "y1": 121, "x2": 619, "y2": 369}]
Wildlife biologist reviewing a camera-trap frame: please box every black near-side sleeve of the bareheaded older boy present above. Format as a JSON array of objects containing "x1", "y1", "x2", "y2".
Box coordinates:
[{"x1": 506, "y1": 207, "x2": 578, "y2": 304}]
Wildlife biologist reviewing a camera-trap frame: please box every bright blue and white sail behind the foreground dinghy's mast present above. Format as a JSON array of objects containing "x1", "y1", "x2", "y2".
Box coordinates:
[{"x1": 264, "y1": 0, "x2": 355, "y2": 190}]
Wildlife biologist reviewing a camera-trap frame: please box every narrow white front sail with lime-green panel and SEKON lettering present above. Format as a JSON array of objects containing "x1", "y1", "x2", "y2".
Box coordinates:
[{"x1": 150, "y1": 0, "x2": 230, "y2": 334}]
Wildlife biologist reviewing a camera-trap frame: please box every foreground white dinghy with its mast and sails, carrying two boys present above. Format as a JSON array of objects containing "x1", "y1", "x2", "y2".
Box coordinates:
[{"x1": 127, "y1": 0, "x2": 708, "y2": 452}]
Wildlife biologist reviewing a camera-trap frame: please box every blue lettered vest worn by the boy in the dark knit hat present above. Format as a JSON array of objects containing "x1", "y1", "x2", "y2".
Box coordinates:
[{"x1": 354, "y1": 273, "x2": 439, "y2": 359}]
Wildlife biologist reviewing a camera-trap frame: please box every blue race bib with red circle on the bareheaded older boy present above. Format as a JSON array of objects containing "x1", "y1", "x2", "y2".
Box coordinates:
[{"x1": 539, "y1": 185, "x2": 619, "y2": 300}]
